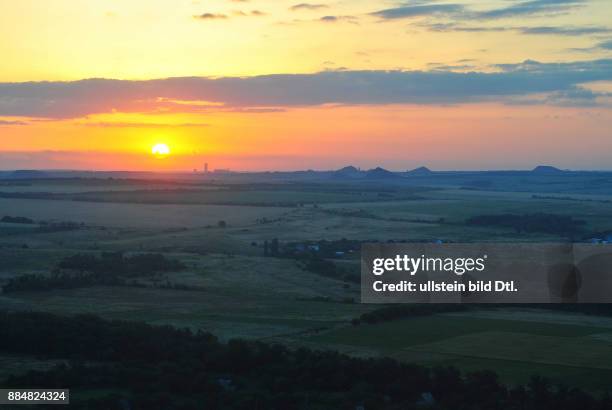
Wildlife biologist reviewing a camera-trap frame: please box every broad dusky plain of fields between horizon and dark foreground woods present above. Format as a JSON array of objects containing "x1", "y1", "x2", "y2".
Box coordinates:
[{"x1": 0, "y1": 176, "x2": 612, "y2": 391}]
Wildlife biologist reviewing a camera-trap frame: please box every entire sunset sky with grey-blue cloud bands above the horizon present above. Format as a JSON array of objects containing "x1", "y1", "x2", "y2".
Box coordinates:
[{"x1": 0, "y1": 0, "x2": 612, "y2": 171}]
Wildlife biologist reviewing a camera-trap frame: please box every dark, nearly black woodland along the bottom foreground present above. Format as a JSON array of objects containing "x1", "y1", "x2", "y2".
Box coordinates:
[{"x1": 0, "y1": 312, "x2": 612, "y2": 410}]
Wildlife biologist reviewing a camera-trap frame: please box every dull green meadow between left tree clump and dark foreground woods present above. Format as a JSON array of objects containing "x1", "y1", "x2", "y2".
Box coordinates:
[{"x1": 0, "y1": 254, "x2": 370, "y2": 338}]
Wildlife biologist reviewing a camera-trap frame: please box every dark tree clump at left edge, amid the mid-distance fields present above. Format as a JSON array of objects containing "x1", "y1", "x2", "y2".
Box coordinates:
[{"x1": 3, "y1": 252, "x2": 185, "y2": 293}]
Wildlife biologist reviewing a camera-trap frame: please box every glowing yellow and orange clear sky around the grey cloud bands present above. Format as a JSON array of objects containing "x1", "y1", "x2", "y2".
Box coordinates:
[{"x1": 0, "y1": 0, "x2": 612, "y2": 170}]
